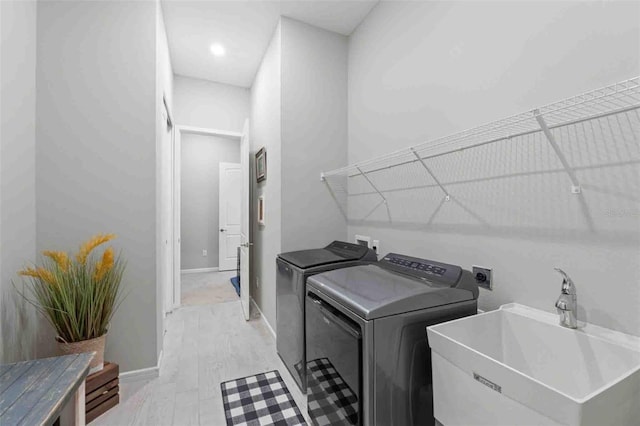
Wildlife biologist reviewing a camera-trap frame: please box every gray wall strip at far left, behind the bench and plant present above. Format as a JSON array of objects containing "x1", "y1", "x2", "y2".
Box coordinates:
[{"x1": 0, "y1": 1, "x2": 42, "y2": 363}]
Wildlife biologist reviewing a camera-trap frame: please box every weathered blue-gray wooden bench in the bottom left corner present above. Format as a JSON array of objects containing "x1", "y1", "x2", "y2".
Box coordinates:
[{"x1": 0, "y1": 353, "x2": 93, "y2": 426}]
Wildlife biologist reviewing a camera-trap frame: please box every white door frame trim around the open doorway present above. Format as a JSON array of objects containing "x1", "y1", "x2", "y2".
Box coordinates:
[{"x1": 171, "y1": 125, "x2": 244, "y2": 309}]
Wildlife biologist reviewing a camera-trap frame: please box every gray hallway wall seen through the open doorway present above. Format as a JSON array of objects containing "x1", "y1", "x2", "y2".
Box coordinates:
[{"x1": 180, "y1": 133, "x2": 240, "y2": 270}]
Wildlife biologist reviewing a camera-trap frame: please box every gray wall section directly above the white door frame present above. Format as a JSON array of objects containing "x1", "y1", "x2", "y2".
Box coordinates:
[{"x1": 174, "y1": 75, "x2": 249, "y2": 132}]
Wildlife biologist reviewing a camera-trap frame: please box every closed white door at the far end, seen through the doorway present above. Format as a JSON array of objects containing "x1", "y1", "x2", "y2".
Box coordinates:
[{"x1": 218, "y1": 163, "x2": 242, "y2": 271}]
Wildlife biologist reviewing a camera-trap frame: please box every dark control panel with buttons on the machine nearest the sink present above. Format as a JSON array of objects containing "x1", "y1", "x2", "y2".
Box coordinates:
[{"x1": 380, "y1": 253, "x2": 462, "y2": 285}]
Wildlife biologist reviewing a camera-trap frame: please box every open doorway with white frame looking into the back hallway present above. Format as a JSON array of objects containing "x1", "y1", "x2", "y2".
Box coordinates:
[{"x1": 173, "y1": 123, "x2": 251, "y2": 319}]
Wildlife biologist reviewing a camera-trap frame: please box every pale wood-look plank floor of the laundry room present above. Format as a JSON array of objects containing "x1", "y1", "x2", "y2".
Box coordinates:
[{"x1": 92, "y1": 301, "x2": 306, "y2": 426}]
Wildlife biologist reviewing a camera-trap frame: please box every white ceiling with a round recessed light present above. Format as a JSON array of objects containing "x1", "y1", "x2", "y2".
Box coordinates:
[{"x1": 162, "y1": 0, "x2": 377, "y2": 87}]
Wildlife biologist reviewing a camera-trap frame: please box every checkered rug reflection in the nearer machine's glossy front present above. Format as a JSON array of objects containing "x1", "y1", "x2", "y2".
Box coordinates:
[{"x1": 307, "y1": 358, "x2": 359, "y2": 425}]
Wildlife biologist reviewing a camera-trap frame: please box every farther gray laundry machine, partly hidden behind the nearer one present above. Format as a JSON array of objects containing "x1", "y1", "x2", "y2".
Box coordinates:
[{"x1": 276, "y1": 241, "x2": 378, "y2": 392}]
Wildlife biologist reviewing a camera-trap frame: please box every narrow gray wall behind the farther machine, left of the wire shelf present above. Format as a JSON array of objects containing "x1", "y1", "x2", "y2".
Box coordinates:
[{"x1": 281, "y1": 18, "x2": 347, "y2": 251}]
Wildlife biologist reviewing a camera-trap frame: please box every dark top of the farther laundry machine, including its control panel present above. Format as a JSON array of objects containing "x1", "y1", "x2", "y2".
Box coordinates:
[{"x1": 278, "y1": 241, "x2": 375, "y2": 269}]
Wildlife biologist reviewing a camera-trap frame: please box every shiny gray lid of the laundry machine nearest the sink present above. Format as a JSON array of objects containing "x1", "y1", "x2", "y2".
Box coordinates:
[{"x1": 307, "y1": 265, "x2": 474, "y2": 320}]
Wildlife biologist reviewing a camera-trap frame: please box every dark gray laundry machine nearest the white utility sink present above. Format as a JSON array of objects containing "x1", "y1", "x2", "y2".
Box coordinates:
[{"x1": 306, "y1": 253, "x2": 478, "y2": 426}]
